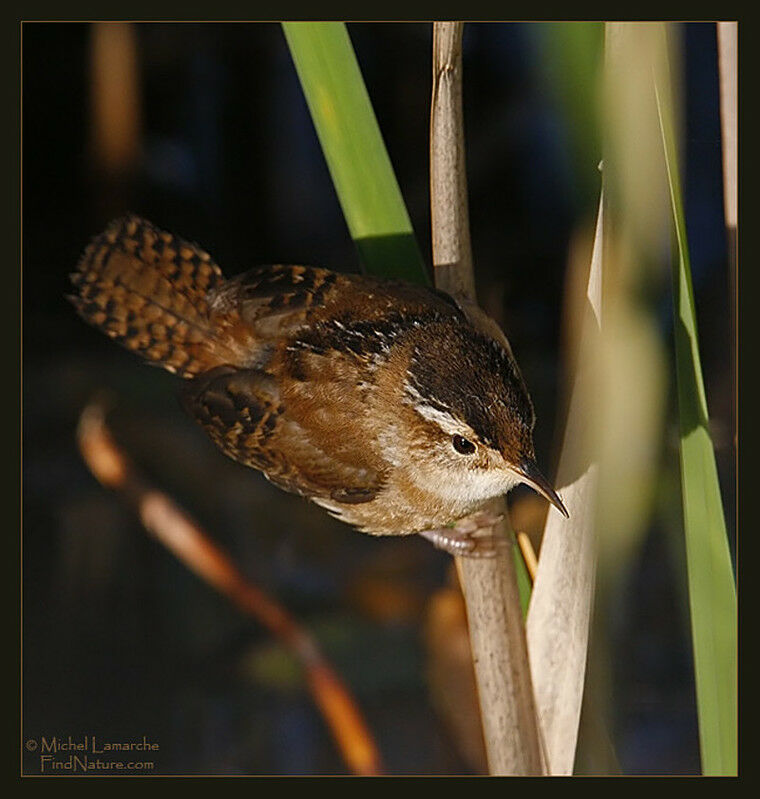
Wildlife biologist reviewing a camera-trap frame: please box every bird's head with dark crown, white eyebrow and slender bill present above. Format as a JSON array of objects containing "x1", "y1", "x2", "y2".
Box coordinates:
[{"x1": 403, "y1": 322, "x2": 568, "y2": 516}]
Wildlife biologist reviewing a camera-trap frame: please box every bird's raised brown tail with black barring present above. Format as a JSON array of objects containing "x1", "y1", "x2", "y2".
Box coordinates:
[{"x1": 70, "y1": 216, "x2": 243, "y2": 377}]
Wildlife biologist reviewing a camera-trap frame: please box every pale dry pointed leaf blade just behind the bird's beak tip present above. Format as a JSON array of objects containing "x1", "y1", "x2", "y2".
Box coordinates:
[{"x1": 526, "y1": 194, "x2": 603, "y2": 774}]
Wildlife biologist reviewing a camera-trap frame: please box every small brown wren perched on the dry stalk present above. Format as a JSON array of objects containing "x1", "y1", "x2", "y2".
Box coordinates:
[{"x1": 69, "y1": 214, "x2": 568, "y2": 556}]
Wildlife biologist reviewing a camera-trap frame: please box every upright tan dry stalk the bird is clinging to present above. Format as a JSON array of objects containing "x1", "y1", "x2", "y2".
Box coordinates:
[{"x1": 430, "y1": 22, "x2": 543, "y2": 774}]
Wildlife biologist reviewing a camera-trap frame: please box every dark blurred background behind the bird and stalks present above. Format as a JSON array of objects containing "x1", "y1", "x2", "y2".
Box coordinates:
[{"x1": 23, "y1": 23, "x2": 735, "y2": 774}]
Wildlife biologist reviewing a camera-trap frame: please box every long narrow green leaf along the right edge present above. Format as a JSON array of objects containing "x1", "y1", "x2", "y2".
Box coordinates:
[{"x1": 655, "y1": 27, "x2": 737, "y2": 775}]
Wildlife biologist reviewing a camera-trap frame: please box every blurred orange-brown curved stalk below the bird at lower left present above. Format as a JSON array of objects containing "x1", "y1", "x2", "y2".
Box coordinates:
[{"x1": 77, "y1": 403, "x2": 382, "y2": 776}]
